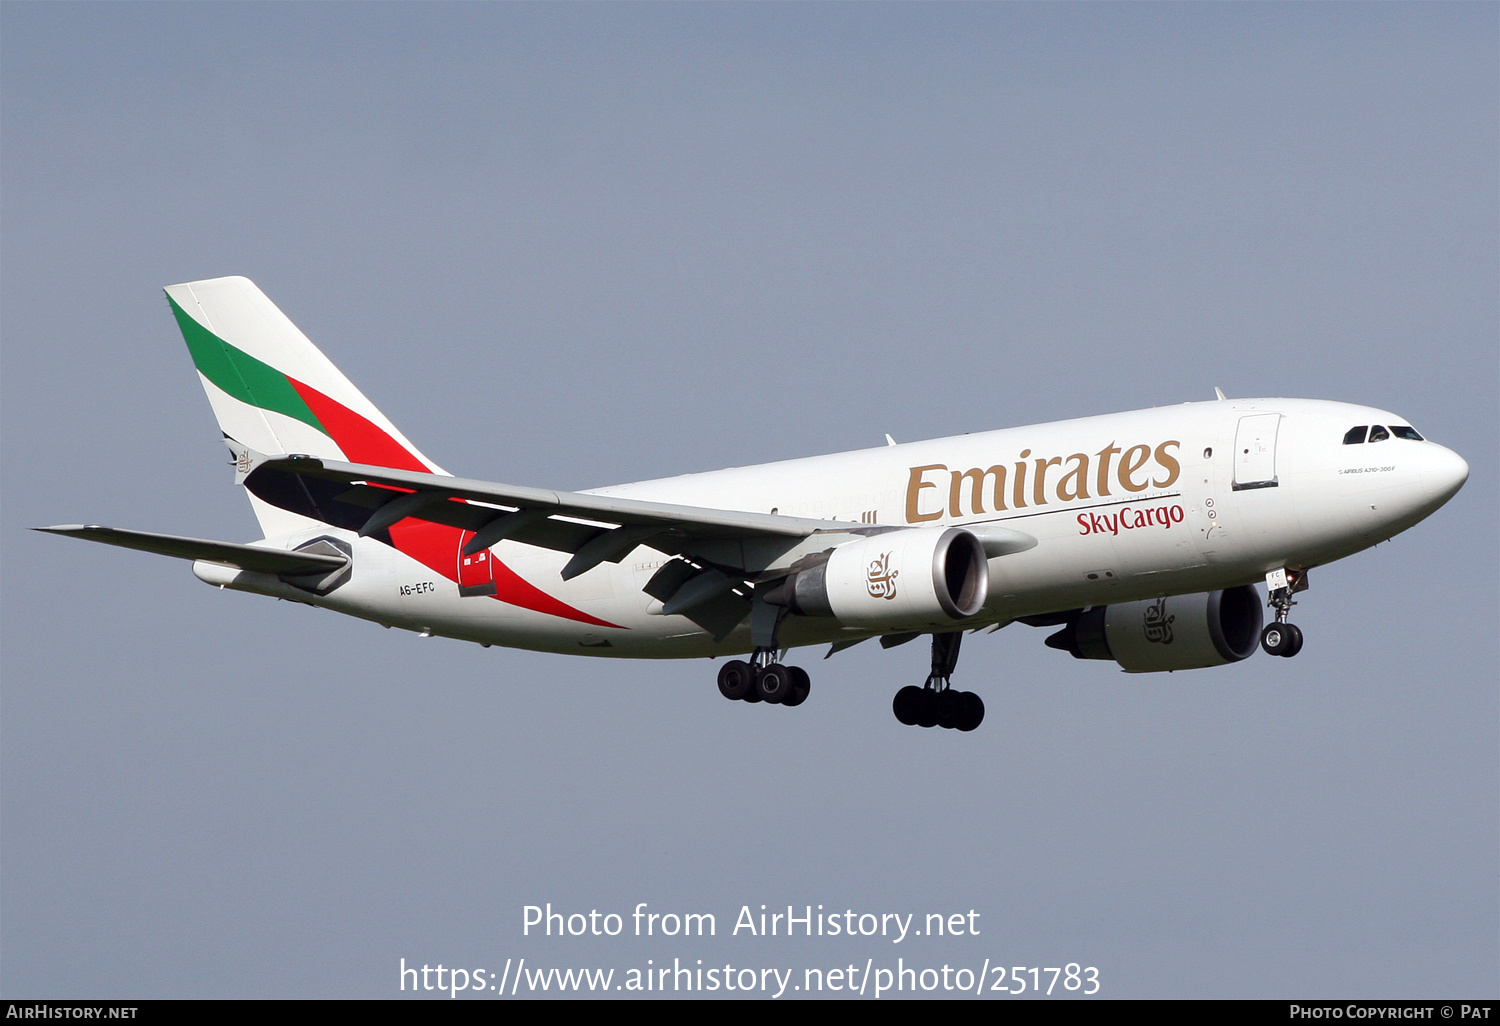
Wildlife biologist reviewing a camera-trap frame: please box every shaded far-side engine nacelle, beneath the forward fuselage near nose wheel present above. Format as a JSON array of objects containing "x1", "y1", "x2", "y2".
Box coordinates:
[{"x1": 1047, "y1": 585, "x2": 1263, "y2": 674}]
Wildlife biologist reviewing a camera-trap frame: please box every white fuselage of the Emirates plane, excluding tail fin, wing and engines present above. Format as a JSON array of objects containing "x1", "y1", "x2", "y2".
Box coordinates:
[{"x1": 205, "y1": 399, "x2": 1469, "y2": 659}]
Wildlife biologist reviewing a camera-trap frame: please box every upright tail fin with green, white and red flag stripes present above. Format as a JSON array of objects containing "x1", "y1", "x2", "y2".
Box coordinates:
[{"x1": 167, "y1": 278, "x2": 447, "y2": 536}]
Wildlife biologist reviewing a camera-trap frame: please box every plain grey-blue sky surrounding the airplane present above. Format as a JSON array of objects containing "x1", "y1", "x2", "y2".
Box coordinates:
[{"x1": 0, "y1": 3, "x2": 1500, "y2": 998}]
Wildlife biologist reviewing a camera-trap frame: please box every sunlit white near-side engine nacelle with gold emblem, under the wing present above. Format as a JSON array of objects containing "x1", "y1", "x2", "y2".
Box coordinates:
[{"x1": 768, "y1": 528, "x2": 990, "y2": 630}]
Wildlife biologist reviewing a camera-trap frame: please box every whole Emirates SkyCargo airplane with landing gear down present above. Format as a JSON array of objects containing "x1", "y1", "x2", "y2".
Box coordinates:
[{"x1": 36, "y1": 278, "x2": 1469, "y2": 732}]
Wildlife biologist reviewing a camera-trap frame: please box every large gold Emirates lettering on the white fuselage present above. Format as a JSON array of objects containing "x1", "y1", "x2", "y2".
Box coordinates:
[{"x1": 906, "y1": 440, "x2": 1182, "y2": 522}]
